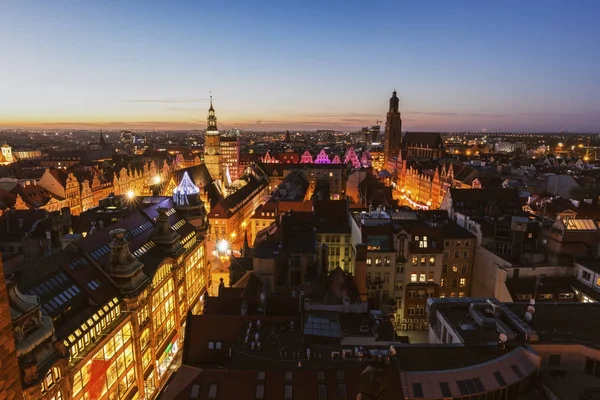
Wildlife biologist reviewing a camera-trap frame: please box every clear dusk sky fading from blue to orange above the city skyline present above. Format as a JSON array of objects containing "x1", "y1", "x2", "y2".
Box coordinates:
[{"x1": 0, "y1": 0, "x2": 600, "y2": 132}]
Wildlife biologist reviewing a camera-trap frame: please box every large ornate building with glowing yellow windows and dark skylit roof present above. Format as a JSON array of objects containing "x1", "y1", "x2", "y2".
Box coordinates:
[{"x1": 17, "y1": 190, "x2": 210, "y2": 400}]
